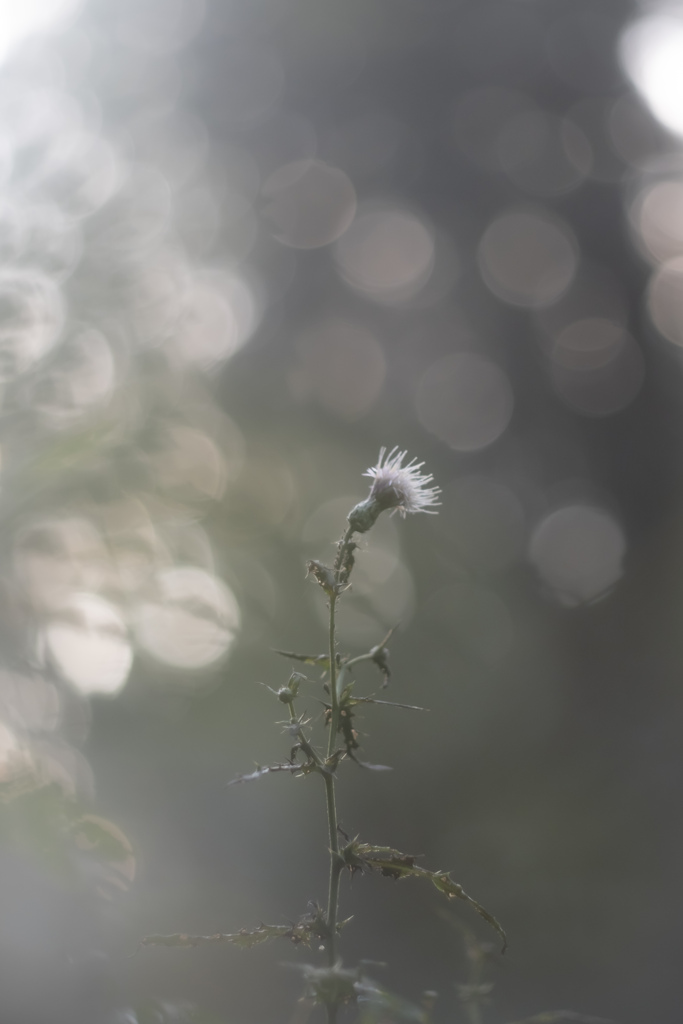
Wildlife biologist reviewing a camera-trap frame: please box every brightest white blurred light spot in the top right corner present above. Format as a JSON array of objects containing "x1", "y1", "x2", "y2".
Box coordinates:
[{"x1": 621, "y1": 13, "x2": 683, "y2": 135}]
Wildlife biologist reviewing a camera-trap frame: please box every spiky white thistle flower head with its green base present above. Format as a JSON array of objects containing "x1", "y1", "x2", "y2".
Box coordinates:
[{"x1": 348, "y1": 447, "x2": 441, "y2": 534}]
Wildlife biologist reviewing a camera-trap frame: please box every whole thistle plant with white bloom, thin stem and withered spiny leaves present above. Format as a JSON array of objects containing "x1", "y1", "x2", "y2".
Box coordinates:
[{"x1": 142, "y1": 447, "x2": 507, "y2": 1024}]
